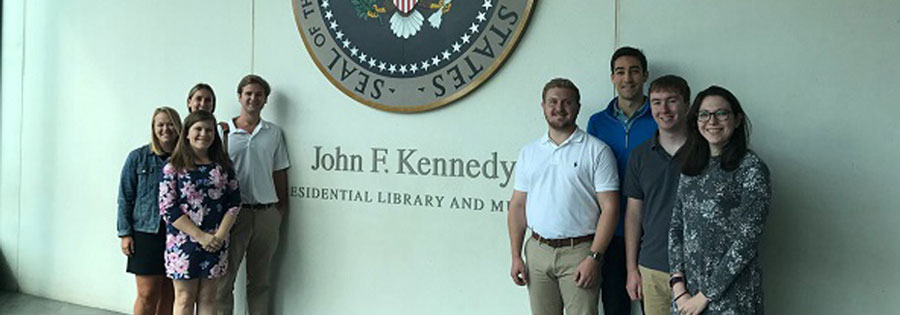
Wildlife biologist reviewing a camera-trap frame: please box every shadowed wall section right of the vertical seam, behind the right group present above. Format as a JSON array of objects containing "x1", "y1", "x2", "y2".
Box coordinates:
[{"x1": 620, "y1": 1, "x2": 900, "y2": 314}]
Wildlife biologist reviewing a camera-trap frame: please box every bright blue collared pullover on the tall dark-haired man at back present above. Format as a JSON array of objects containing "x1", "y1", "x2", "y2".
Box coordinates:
[{"x1": 587, "y1": 97, "x2": 657, "y2": 237}]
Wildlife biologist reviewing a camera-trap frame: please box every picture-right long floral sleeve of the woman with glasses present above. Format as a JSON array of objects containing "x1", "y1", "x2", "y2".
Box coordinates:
[{"x1": 700, "y1": 160, "x2": 772, "y2": 301}]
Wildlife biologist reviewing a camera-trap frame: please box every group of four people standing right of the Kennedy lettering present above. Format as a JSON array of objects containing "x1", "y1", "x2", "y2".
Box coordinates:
[{"x1": 508, "y1": 47, "x2": 771, "y2": 315}]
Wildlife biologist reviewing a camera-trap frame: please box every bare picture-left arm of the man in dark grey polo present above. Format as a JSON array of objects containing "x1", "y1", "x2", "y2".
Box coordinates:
[{"x1": 625, "y1": 198, "x2": 644, "y2": 300}]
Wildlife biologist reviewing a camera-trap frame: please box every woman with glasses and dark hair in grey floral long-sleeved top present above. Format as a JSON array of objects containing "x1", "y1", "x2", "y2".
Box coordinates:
[{"x1": 669, "y1": 86, "x2": 771, "y2": 315}]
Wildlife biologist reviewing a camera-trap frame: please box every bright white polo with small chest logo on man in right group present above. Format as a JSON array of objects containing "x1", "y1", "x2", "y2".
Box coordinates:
[{"x1": 515, "y1": 127, "x2": 619, "y2": 239}]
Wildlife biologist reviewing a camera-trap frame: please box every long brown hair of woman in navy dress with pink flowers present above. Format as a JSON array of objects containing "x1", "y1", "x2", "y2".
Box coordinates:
[{"x1": 169, "y1": 110, "x2": 232, "y2": 172}]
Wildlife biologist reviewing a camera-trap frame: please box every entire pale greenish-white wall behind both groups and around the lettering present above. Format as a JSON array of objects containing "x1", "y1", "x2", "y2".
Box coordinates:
[{"x1": 0, "y1": 0, "x2": 900, "y2": 314}]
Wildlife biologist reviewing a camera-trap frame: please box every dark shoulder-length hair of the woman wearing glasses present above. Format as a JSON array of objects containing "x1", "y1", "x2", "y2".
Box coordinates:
[{"x1": 676, "y1": 85, "x2": 750, "y2": 176}]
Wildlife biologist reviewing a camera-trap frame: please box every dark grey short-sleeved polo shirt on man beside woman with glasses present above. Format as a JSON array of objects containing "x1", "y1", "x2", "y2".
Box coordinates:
[{"x1": 622, "y1": 133, "x2": 681, "y2": 272}]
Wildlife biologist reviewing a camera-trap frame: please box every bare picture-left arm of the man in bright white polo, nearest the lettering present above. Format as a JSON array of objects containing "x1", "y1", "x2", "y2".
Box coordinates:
[{"x1": 506, "y1": 190, "x2": 528, "y2": 285}]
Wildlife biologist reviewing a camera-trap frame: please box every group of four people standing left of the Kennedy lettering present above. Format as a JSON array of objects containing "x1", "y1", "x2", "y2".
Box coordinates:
[{"x1": 117, "y1": 74, "x2": 290, "y2": 314}]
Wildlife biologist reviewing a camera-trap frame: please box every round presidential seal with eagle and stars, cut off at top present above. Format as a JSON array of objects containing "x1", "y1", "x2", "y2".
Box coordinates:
[{"x1": 292, "y1": 0, "x2": 534, "y2": 112}]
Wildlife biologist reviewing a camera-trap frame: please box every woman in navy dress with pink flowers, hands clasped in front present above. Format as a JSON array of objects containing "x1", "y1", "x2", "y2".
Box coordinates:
[{"x1": 159, "y1": 110, "x2": 241, "y2": 314}]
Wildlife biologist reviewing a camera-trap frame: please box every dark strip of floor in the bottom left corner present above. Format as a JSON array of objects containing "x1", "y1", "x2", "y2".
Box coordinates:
[{"x1": 0, "y1": 291, "x2": 122, "y2": 315}]
